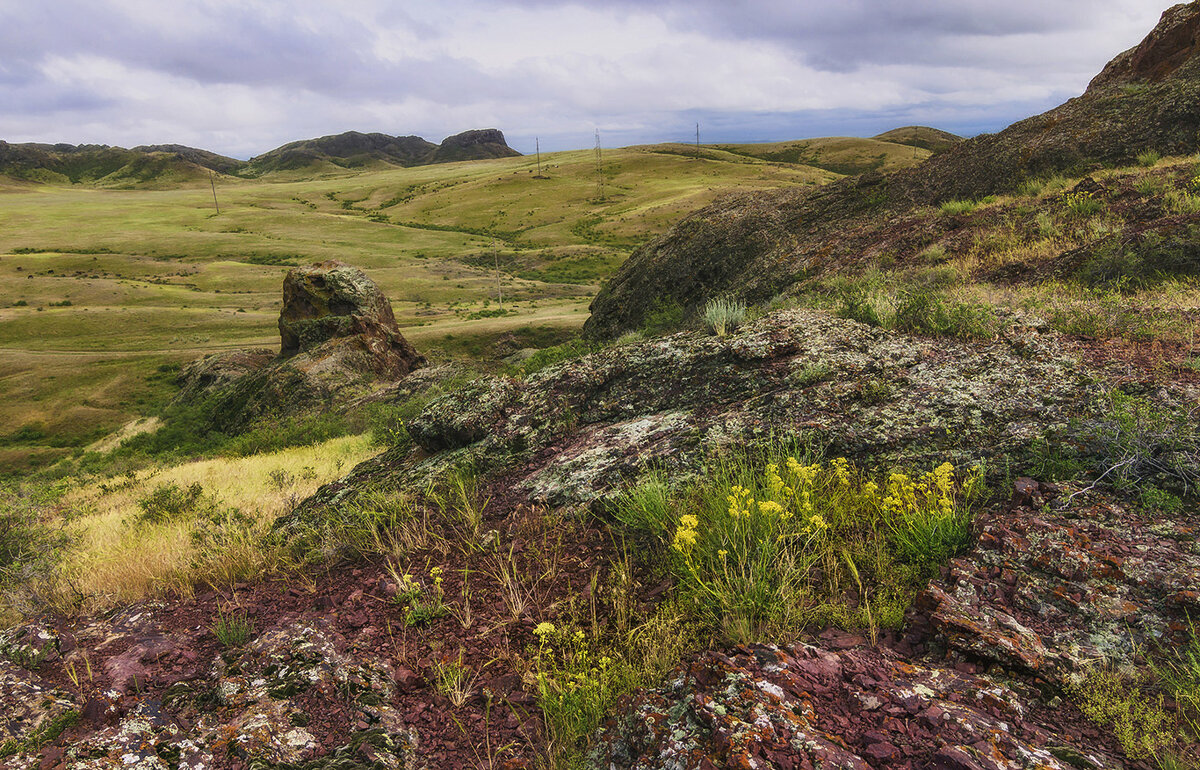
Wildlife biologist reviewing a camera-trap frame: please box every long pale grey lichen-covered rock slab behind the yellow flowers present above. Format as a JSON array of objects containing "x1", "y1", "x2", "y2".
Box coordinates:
[{"x1": 393, "y1": 311, "x2": 1093, "y2": 505}]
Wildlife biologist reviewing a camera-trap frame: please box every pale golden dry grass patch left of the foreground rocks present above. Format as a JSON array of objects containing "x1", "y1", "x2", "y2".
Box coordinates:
[{"x1": 52, "y1": 437, "x2": 377, "y2": 609}]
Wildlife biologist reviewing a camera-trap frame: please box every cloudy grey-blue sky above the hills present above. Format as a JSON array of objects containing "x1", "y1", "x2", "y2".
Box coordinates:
[{"x1": 0, "y1": 0, "x2": 1169, "y2": 158}]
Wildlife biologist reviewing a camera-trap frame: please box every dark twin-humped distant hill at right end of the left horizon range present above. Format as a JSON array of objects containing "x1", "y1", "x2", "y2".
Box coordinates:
[{"x1": 241, "y1": 128, "x2": 521, "y2": 176}]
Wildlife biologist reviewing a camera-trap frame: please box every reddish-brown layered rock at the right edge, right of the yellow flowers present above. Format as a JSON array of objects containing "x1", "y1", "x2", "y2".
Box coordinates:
[{"x1": 918, "y1": 479, "x2": 1200, "y2": 685}]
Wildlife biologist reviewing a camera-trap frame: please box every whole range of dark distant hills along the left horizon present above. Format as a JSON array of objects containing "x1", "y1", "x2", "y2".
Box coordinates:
[{"x1": 0, "y1": 128, "x2": 521, "y2": 187}]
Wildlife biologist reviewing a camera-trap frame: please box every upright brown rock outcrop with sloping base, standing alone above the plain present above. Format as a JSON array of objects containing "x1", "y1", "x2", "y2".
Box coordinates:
[{"x1": 176, "y1": 261, "x2": 425, "y2": 434}]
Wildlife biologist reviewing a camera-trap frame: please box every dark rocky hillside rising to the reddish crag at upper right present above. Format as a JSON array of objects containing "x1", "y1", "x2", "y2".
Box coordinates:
[{"x1": 586, "y1": 1, "x2": 1200, "y2": 338}]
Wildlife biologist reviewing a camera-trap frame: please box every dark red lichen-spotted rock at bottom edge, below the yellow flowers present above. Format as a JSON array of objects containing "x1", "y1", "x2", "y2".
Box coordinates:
[{"x1": 593, "y1": 645, "x2": 1122, "y2": 770}]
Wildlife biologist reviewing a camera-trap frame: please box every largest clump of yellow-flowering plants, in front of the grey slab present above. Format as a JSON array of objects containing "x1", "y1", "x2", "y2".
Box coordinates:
[{"x1": 614, "y1": 450, "x2": 982, "y2": 642}]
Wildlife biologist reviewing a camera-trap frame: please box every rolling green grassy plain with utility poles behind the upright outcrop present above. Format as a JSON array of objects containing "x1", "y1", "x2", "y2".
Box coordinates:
[{"x1": 0, "y1": 140, "x2": 925, "y2": 474}]
